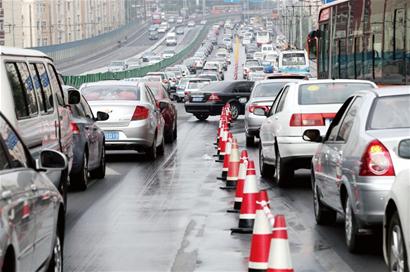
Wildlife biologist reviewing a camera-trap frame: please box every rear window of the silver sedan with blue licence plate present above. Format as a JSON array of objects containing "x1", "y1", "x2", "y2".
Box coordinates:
[{"x1": 81, "y1": 85, "x2": 140, "y2": 101}]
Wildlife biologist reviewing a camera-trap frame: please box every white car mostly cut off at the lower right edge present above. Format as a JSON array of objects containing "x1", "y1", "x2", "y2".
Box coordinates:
[{"x1": 383, "y1": 143, "x2": 410, "y2": 272}]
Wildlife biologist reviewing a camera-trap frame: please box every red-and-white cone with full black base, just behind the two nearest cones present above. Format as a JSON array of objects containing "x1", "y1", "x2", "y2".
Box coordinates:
[{"x1": 231, "y1": 160, "x2": 259, "y2": 233}]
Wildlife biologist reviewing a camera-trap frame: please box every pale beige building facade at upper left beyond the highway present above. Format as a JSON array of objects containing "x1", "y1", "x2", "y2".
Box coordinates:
[{"x1": 2, "y1": 0, "x2": 127, "y2": 47}]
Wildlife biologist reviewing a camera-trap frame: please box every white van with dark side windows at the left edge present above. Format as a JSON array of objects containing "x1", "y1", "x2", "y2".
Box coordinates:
[{"x1": 0, "y1": 46, "x2": 81, "y2": 206}]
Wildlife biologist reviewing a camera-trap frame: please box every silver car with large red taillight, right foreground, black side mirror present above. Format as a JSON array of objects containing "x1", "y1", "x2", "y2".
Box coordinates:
[{"x1": 303, "y1": 87, "x2": 410, "y2": 251}]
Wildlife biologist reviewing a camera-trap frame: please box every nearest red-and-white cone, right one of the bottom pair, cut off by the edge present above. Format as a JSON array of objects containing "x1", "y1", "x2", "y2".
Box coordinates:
[{"x1": 267, "y1": 215, "x2": 294, "y2": 272}]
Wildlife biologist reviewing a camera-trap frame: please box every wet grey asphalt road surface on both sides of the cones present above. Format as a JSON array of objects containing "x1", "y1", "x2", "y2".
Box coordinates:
[{"x1": 64, "y1": 37, "x2": 386, "y2": 272}]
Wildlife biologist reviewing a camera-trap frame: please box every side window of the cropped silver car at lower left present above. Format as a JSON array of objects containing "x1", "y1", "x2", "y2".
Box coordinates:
[{"x1": 0, "y1": 118, "x2": 29, "y2": 168}]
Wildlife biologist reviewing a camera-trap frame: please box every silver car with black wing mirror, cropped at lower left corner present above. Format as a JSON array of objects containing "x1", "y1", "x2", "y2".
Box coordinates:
[{"x1": 0, "y1": 113, "x2": 67, "y2": 271}]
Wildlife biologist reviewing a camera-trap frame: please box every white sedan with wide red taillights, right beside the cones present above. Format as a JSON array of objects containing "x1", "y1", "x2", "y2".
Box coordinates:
[{"x1": 259, "y1": 80, "x2": 376, "y2": 181}]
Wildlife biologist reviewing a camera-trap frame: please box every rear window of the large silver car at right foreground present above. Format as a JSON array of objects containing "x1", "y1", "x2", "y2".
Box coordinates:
[{"x1": 368, "y1": 95, "x2": 410, "y2": 129}]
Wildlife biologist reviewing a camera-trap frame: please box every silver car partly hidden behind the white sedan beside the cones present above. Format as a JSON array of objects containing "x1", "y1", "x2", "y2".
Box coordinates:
[{"x1": 245, "y1": 79, "x2": 298, "y2": 146}]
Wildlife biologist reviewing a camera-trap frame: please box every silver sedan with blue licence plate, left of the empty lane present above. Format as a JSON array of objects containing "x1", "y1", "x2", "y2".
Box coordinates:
[{"x1": 80, "y1": 80, "x2": 164, "y2": 160}]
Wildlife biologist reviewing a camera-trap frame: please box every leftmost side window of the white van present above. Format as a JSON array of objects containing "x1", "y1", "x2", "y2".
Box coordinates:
[{"x1": 6, "y1": 62, "x2": 38, "y2": 120}]
